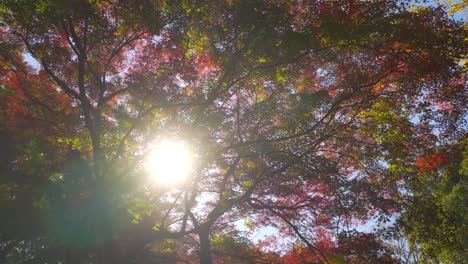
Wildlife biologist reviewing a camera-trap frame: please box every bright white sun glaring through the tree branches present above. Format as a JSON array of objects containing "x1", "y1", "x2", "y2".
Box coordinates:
[{"x1": 144, "y1": 140, "x2": 192, "y2": 185}]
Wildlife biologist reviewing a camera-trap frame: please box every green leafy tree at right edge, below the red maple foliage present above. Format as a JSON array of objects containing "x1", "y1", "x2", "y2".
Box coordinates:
[{"x1": 402, "y1": 139, "x2": 468, "y2": 263}]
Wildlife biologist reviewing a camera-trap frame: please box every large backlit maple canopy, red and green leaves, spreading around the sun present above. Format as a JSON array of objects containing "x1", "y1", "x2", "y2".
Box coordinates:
[{"x1": 0, "y1": 0, "x2": 466, "y2": 263}]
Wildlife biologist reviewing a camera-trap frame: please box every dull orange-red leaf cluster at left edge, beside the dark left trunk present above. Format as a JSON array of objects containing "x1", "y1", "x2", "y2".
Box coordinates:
[{"x1": 0, "y1": 65, "x2": 77, "y2": 142}]
